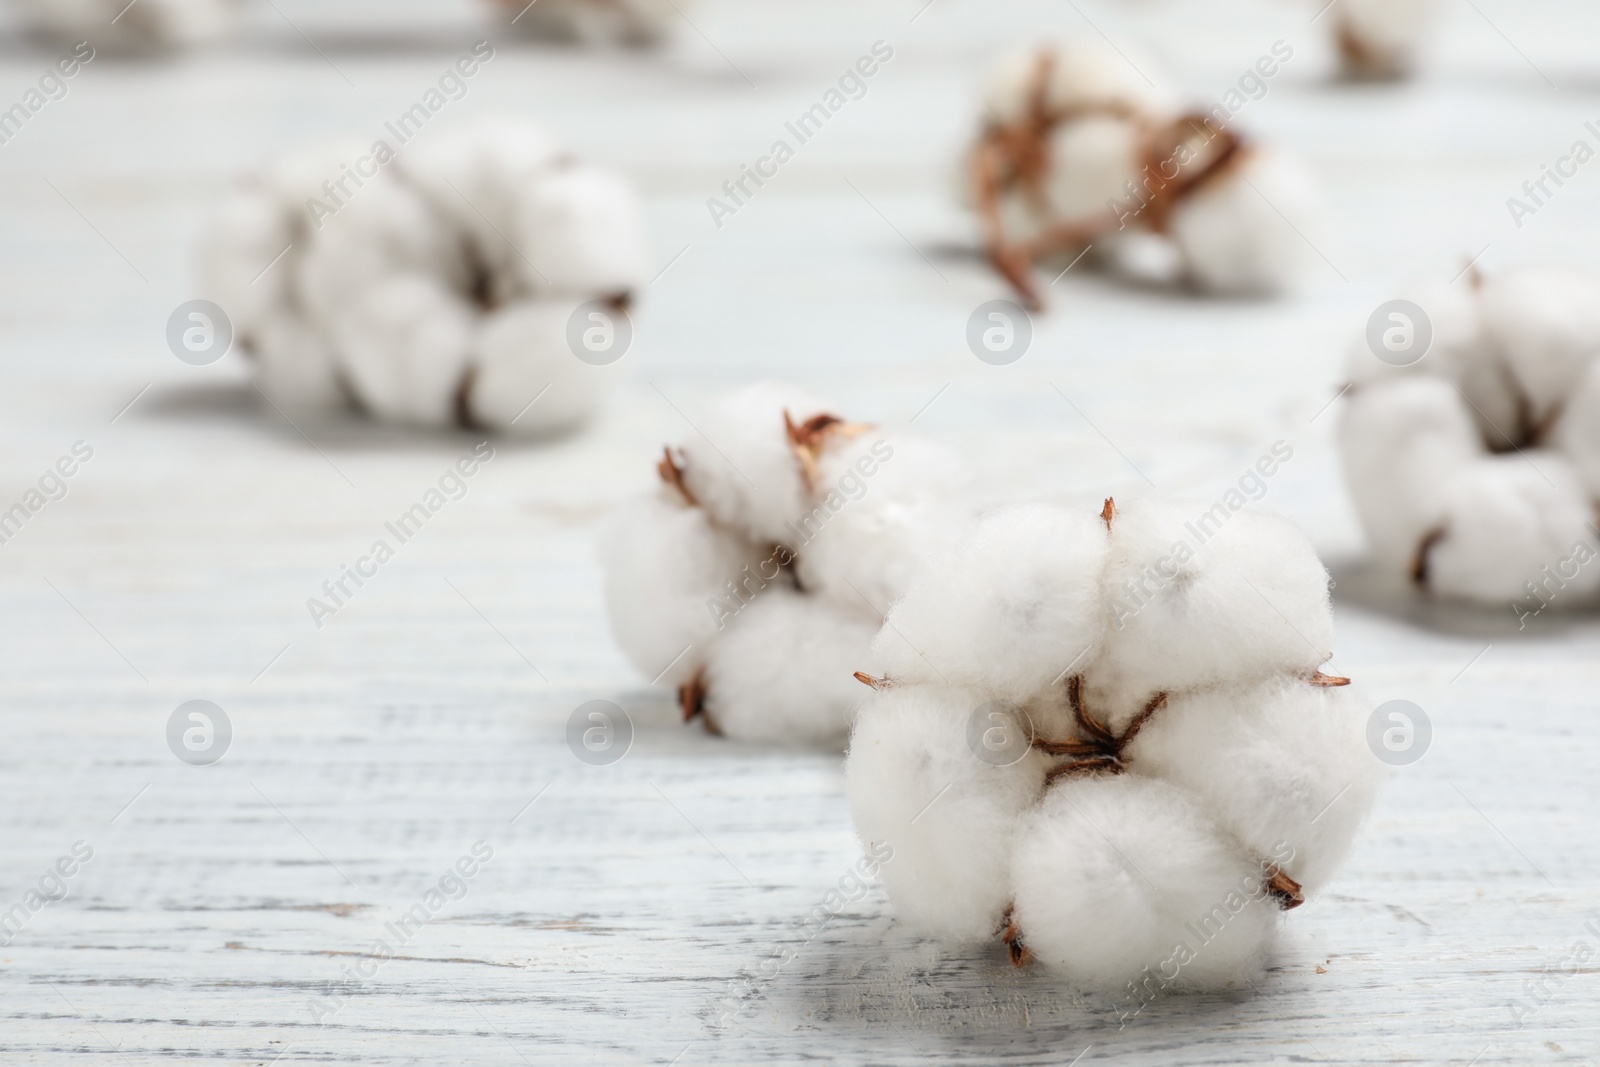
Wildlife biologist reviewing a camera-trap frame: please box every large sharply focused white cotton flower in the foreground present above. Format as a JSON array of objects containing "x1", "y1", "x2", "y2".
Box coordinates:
[{"x1": 846, "y1": 501, "x2": 1382, "y2": 989}]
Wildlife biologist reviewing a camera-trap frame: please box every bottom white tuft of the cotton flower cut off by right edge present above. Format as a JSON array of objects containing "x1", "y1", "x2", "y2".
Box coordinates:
[{"x1": 1421, "y1": 450, "x2": 1600, "y2": 603}]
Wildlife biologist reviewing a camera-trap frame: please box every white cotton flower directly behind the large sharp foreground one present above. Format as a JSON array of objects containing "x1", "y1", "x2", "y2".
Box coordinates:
[{"x1": 600, "y1": 382, "x2": 962, "y2": 747}]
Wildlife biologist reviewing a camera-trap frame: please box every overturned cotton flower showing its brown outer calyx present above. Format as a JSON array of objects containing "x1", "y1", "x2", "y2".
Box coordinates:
[{"x1": 968, "y1": 42, "x2": 1320, "y2": 307}]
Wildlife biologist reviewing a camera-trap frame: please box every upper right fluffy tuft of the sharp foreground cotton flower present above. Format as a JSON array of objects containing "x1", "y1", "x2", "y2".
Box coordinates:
[{"x1": 1082, "y1": 494, "x2": 1333, "y2": 733}]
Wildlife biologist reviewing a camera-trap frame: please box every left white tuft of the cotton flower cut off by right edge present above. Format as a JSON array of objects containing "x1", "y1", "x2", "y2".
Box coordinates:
[{"x1": 1339, "y1": 376, "x2": 1483, "y2": 571}]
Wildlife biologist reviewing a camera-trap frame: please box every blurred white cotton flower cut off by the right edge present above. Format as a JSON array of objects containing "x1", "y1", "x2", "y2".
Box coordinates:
[{"x1": 1341, "y1": 269, "x2": 1600, "y2": 607}]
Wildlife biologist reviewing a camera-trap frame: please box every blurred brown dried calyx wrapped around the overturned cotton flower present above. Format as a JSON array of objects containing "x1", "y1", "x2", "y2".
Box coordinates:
[{"x1": 971, "y1": 51, "x2": 1246, "y2": 310}]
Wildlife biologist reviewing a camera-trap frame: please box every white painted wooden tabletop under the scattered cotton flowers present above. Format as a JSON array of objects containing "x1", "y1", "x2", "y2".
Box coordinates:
[{"x1": 0, "y1": 0, "x2": 1600, "y2": 1065}]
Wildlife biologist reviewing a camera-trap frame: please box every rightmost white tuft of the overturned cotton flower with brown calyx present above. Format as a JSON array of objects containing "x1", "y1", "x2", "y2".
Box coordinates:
[{"x1": 1170, "y1": 147, "x2": 1322, "y2": 296}]
